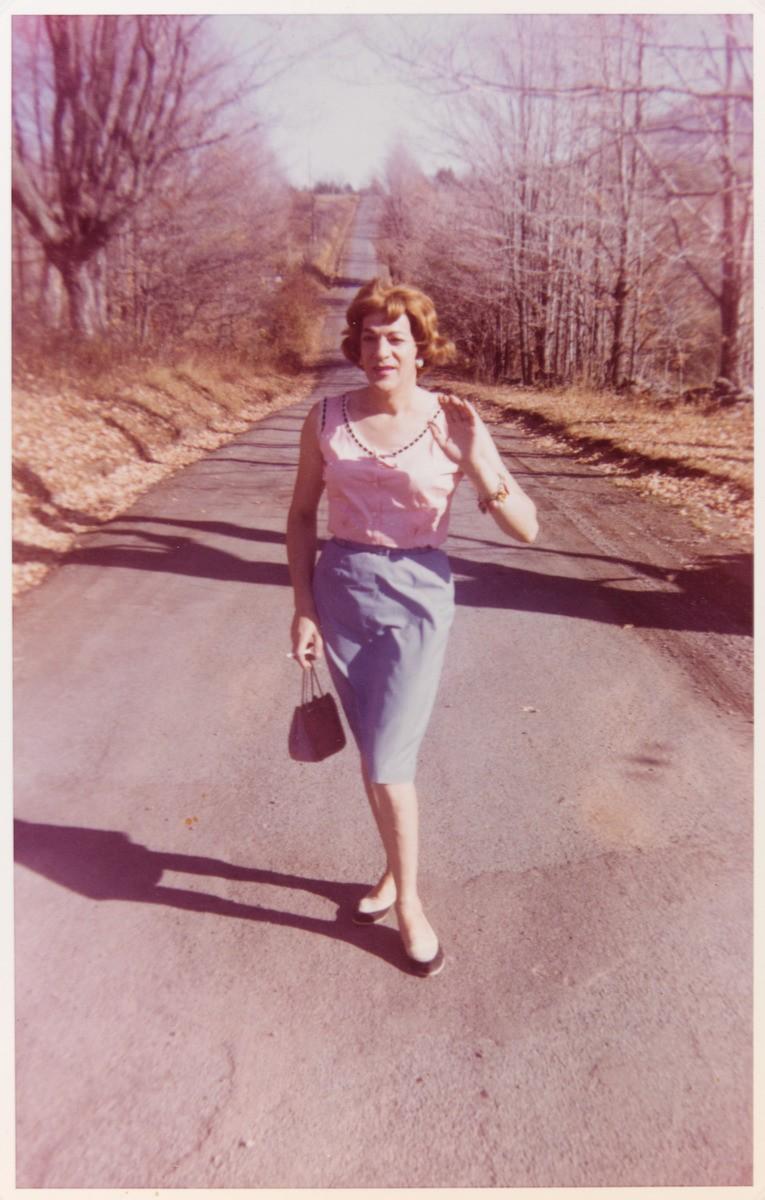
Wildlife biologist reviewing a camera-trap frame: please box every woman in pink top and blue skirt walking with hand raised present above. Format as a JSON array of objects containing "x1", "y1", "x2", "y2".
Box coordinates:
[{"x1": 287, "y1": 280, "x2": 537, "y2": 976}]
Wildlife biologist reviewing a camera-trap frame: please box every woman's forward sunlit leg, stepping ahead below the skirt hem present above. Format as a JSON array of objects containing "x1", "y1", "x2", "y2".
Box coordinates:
[{"x1": 371, "y1": 782, "x2": 439, "y2": 962}]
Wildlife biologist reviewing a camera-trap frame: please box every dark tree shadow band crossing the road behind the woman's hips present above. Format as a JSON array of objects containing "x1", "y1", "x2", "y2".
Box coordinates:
[{"x1": 32, "y1": 514, "x2": 752, "y2": 636}]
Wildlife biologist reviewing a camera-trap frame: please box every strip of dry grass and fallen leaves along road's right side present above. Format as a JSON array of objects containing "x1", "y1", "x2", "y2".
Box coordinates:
[{"x1": 434, "y1": 374, "x2": 754, "y2": 550}]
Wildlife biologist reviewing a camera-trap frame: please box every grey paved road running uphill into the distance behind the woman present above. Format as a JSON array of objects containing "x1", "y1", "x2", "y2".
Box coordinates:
[{"x1": 16, "y1": 199, "x2": 752, "y2": 1188}]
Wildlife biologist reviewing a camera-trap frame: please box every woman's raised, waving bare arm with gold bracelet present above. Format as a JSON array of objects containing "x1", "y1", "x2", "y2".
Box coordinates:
[{"x1": 432, "y1": 396, "x2": 540, "y2": 542}]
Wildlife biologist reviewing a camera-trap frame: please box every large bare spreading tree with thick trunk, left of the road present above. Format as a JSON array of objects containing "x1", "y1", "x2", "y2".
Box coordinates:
[{"x1": 12, "y1": 16, "x2": 269, "y2": 335}]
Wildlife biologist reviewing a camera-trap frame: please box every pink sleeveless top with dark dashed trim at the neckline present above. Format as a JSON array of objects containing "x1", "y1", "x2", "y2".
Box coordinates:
[{"x1": 319, "y1": 396, "x2": 463, "y2": 550}]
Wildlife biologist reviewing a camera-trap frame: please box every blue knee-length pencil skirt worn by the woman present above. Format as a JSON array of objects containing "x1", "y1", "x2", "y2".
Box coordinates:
[{"x1": 313, "y1": 539, "x2": 454, "y2": 784}]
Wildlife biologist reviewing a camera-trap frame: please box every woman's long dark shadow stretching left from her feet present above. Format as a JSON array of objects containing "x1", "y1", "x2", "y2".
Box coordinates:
[{"x1": 13, "y1": 820, "x2": 406, "y2": 971}]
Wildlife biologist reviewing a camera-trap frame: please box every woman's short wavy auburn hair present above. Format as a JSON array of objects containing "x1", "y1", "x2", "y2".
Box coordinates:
[{"x1": 341, "y1": 278, "x2": 457, "y2": 366}]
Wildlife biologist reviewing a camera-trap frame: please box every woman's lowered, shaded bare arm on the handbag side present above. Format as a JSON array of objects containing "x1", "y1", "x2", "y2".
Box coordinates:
[{"x1": 287, "y1": 404, "x2": 324, "y2": 668}]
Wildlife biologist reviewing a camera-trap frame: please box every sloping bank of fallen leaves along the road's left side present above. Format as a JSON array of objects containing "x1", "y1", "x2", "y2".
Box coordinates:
[{"x1": 13, "y1": 359, "x2": 315, "y2": 594}]
